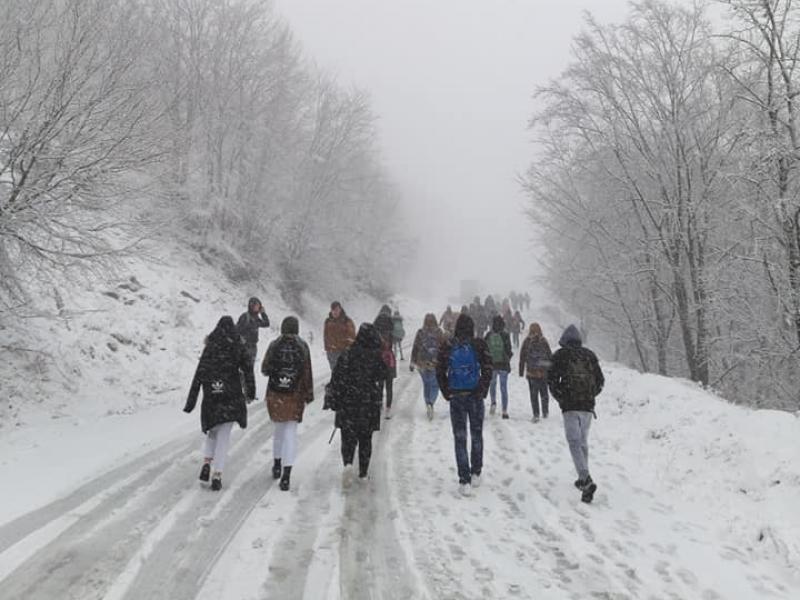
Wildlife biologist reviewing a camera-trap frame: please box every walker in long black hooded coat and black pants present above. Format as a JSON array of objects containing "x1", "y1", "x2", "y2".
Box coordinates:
[{"x1": 330, "y1": 323, "x2": 389, "y2": 486}]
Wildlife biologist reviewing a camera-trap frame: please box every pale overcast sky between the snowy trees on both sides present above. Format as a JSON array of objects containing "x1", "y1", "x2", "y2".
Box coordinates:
[{"x1": 275, "y1": 0, "x2": 628, "y2": 297}]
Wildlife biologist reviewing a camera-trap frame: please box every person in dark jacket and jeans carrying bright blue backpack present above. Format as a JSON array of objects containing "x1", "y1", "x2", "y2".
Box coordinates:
[{"x1": 436, "y1": 315, "x2": 492, "y2": 496}]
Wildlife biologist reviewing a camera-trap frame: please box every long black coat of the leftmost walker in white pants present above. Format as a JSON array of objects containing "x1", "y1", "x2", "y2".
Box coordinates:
[{"x1": 183, "y1": 316, "x2": 256, "y2": 433}]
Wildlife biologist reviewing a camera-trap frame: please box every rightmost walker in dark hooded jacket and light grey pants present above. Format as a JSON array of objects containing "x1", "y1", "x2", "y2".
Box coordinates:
[{"x1": 547, "y1": 325, "x2": 605, "y2": 503}]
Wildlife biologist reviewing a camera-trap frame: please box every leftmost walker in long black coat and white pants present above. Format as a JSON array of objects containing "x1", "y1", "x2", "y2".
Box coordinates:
[{"x1": 183, "y1": 315, "x2": 256, "y2": 491}]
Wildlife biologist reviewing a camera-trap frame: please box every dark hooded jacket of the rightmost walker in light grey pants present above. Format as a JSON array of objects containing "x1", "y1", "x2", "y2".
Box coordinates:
[{"x1": 547, "y1": 325, "x2": 605, "y2": 412}]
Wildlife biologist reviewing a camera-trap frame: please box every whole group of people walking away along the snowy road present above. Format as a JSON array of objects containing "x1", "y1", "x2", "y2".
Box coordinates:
[{"x1": 184, "y1": 293, "x2": 604, "y2": 502}]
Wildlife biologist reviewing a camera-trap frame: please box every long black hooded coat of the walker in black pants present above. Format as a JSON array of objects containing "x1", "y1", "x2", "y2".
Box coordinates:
[{"x1": 330, "y1": 323, "x2": 389, "y2": 432}]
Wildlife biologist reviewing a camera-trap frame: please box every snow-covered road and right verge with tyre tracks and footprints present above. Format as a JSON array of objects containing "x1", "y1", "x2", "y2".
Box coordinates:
[{"x1": 0, "y1": 363, "x2": 800, "y2": 600}]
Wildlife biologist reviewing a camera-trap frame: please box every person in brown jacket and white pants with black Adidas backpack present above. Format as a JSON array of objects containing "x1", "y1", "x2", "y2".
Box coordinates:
[{"x1": 261, "y1": 317, "x2": 314, "y2": 491}]
